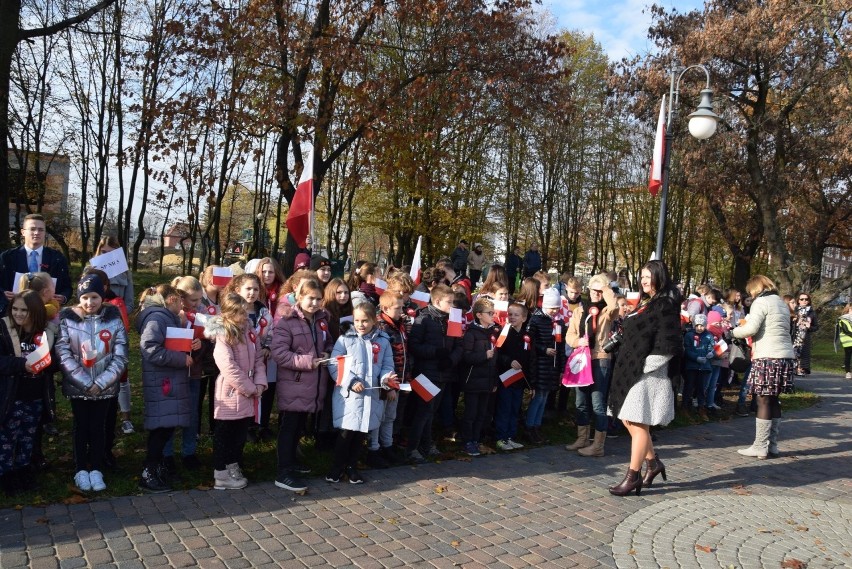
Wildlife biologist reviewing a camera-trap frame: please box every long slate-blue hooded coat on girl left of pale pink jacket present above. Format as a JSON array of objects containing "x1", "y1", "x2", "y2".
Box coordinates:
[{"x1": 136, "y1": 306, "x2": 192, "y2": 431}]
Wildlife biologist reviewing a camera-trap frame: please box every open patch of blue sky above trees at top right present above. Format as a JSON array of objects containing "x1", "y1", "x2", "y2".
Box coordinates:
[{"x1": 541, "y1": 0, "x2": 704, "y2": 61}]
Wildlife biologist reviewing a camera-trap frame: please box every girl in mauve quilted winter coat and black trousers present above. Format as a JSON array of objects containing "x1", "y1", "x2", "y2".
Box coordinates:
[{"x1": 271, "y1": 280, "x2": 334, "y2": 492}]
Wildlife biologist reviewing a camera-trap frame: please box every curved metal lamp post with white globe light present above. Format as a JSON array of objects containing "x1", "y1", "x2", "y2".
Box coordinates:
[{"x1": 655, "y1": 65, "x2": 721, "y2": 259}]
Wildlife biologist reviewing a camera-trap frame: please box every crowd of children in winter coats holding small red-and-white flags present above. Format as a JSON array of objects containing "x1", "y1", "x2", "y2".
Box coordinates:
[{"x1": 0, "y1": 245, "x2": 852, "y2": 492}]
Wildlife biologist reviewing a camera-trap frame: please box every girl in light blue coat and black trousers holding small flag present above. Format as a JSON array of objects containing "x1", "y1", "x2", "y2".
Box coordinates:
[{"x1": 325, "y1": 302, "x2": 398, "y2": 484}]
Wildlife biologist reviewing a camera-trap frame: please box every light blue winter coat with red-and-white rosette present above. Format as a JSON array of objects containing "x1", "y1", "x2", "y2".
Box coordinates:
[{"x1": 328, "y1": 328, "x2": 394, "y2": 433}]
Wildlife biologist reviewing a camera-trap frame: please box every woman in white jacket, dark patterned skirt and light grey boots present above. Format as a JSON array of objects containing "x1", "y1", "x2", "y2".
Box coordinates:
[{"x1": 733, "y1": 275, "x2": 796, "y2": 459}]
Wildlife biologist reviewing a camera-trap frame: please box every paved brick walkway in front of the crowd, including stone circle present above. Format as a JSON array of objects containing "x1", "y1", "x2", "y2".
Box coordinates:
[{"x1": 0, "y1": 376, "x2": 852, "y2": 569}]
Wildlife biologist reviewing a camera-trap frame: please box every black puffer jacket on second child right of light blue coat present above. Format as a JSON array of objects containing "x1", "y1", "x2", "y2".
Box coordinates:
[{"x1": 408, "y1": 305, "x2": 462, "y2": 383}]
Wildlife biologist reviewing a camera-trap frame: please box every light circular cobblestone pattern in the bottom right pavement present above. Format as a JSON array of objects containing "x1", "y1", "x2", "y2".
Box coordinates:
[{"x1": 612, "y1": 495, "x2": 852, "y2": 569}]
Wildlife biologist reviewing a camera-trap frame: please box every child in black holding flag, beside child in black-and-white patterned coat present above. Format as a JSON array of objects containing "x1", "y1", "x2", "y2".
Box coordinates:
[{"x1": 494, "y1": 302, "x2": 535, "y2": 451}]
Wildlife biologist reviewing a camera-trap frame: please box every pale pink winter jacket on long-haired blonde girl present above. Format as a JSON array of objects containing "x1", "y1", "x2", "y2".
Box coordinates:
[{"x1": 204, "y1": 316, "x2": 267, "y2": 421}]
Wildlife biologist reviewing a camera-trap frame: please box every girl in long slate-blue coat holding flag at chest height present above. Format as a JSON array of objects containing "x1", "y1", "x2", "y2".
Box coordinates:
[{"x1": 136, "y1": 284, "x2": 193, "y2": 493}]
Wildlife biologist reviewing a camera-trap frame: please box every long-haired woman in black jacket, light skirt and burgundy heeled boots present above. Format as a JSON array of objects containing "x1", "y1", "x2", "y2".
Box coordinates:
[{"x1": 609, "y1": 261, "x2": 683, "y2": 496}]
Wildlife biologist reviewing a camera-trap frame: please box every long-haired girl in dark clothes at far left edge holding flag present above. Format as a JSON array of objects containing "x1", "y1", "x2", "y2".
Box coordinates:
[{"x1": 0, "y1": 291, "x2": 54, "y2": 494}]
